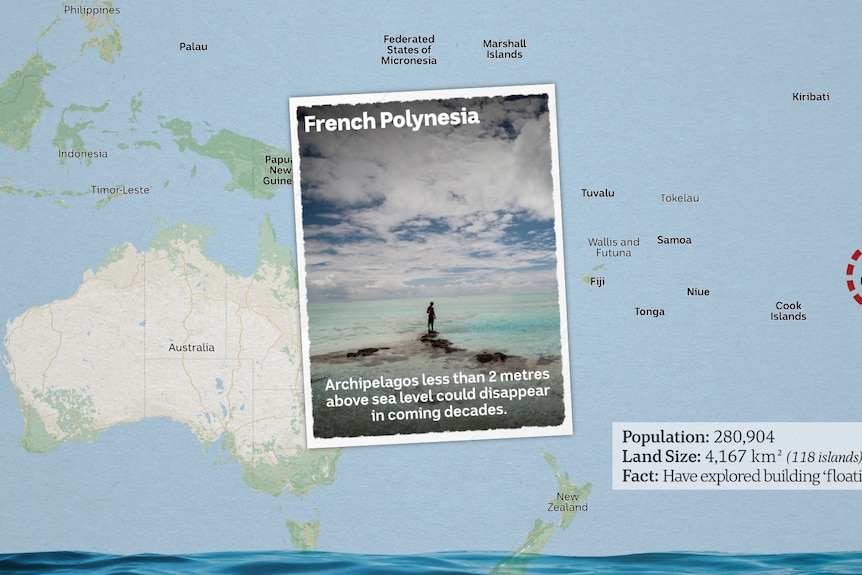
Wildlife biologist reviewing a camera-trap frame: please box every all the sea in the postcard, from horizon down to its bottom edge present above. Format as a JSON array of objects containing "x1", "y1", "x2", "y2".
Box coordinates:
[{"x1": 309, "y1": 294, "x2": 566, "y2": 437}]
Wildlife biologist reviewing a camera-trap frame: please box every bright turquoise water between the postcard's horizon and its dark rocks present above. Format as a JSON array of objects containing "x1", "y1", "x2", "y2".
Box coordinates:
[{"x1": 308, "y1": 293, "x2": 561, "y2": 358}]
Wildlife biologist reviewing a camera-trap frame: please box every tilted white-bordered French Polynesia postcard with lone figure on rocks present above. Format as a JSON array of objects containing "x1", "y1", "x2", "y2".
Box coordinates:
[{"x1": 291, "y1": 85, "x2": 572, "y2": 447}]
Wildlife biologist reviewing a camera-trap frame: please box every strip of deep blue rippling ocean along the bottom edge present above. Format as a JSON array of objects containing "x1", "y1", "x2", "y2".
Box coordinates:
[{"x1": 0, "y1": 551, "x2": 862, "y2": 575}]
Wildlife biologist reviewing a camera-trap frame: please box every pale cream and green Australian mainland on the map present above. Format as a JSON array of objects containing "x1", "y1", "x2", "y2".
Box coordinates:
[{"x1": 6, "y1": 218, "x2": 340, "y2": 495}]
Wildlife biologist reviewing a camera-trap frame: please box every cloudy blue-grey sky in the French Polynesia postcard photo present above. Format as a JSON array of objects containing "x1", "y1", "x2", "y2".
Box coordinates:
[{"x1": 297, "y1": 94, "x2": 557, "y2": 302}]
